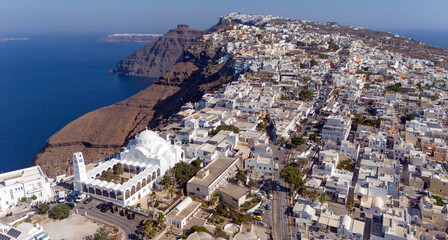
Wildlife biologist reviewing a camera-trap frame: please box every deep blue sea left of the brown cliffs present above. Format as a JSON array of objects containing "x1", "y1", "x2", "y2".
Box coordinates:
[{"x1": 0, "y1": 34, "x2": 153, "y2": 172}]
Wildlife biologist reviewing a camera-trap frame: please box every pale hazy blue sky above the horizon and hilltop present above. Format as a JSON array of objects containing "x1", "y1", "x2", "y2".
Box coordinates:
[{"x1": 0, "y1": 0, "x2": 448, "y2": 35}]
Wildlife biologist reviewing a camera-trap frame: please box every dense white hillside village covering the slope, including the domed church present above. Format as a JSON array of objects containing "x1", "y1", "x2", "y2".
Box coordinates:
[{"x1": 0, "y1": 13, "x2": 448, "y2": 240}]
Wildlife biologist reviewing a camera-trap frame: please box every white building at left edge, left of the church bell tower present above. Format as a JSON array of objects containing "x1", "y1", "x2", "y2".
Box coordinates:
[{"x1": 0, "y1": 166, "x2": 54, "y2": 215}]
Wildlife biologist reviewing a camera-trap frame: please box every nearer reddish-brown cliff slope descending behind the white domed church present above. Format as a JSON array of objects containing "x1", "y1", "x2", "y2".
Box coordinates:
[{"x1": 34, "y1": 37, "x2": 233, "y2": 177}]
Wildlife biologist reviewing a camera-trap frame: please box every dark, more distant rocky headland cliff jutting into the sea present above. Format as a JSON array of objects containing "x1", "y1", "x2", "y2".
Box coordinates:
[{"x1": 117, "y1": 25, "x2": 204, "y2": 77}]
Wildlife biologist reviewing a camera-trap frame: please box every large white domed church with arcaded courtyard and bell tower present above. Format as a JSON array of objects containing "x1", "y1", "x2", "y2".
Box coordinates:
[{"x1": 73, "y1": 129, "x2": 184, "y2": 206}]
